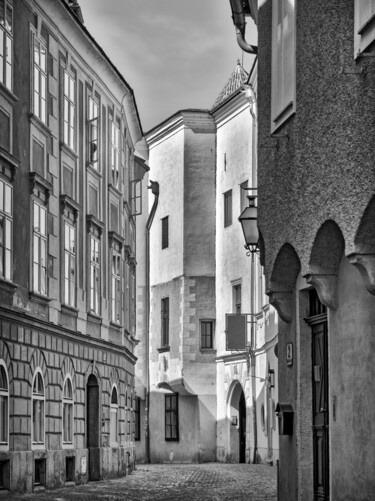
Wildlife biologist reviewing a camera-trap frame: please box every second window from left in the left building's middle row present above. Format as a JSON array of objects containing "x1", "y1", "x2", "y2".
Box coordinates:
[{"x1": 33, "y1": 202, "x2": 47, "y2": 295}]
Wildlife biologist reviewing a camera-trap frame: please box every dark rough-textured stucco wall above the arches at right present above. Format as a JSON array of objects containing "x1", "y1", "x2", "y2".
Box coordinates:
[{"x1": 258, "y1": 0, "x2": 375, "y2": 283}]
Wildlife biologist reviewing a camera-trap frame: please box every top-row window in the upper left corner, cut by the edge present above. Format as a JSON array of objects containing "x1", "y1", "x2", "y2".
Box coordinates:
[{"x1": 0, "y1": 0, "x2": 14, "y2": 92}]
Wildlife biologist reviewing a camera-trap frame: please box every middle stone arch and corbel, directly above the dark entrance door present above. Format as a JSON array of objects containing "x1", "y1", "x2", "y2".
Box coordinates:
[{"x1": 305, "y1": 219, "x2": 345, "y2": 309}]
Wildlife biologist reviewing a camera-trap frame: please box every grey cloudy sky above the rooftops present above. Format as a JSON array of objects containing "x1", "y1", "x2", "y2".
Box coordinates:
[{"x1": 79, "y1": 0, "x2": 256, "y2": 131}]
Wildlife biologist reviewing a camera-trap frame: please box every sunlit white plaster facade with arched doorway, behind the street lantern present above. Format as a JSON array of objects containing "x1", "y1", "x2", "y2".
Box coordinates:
[{"x1": 212, "y1": 62, "x2": 278, "y2": 463}]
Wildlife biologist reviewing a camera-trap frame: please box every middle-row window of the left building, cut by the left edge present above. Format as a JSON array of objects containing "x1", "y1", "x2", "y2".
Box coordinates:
[{"x1": 0, "y1": 179, "x2": 13, "y2": 280}]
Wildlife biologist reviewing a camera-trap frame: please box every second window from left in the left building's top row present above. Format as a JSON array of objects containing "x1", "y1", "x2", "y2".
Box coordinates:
[{"x1": 33, "y1": 36, "x2": 47, "y2": 123}]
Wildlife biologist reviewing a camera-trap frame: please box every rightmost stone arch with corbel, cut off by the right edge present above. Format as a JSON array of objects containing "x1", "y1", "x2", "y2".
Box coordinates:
[{"x1": 348, "y1": 195, "x2": 375, "y2": 295}]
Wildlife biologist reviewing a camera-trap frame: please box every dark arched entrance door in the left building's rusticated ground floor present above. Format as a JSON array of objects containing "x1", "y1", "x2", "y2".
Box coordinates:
[{"x1": 86, "y1": 374, "x2": 100, "y2": 480}]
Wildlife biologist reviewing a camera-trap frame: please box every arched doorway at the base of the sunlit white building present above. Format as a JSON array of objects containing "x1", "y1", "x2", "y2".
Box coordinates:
[{"x1": 228, "y1": 382, "x2": 246, "y2": 463}]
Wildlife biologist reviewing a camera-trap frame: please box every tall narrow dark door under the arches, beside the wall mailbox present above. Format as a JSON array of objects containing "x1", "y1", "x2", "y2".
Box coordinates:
[{"x1": 309, "y1": 291, "x2": 329, "y2": 500}]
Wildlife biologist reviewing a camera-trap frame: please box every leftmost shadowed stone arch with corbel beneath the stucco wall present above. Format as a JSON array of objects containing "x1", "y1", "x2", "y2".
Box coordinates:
[{"x1": 267, "y1": 243, "x2": 301, "y2": 322}]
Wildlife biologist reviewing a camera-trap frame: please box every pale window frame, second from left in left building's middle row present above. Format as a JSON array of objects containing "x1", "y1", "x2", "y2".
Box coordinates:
[{"x1": 32, "y1": 199, "x2": 48, "y2": 296}]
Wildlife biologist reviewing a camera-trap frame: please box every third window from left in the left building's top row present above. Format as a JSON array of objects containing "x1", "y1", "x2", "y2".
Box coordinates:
[{"x1": 62, "y1": 68, "x2": 77, "y2": 151}]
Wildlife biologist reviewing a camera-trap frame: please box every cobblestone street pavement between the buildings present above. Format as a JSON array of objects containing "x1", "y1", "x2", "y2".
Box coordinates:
[{"x1": 8, "y1": 463, "x2": 276, "y2": 501}]
